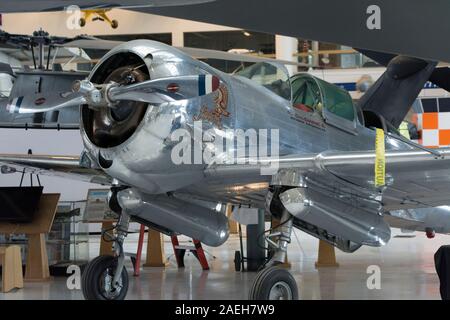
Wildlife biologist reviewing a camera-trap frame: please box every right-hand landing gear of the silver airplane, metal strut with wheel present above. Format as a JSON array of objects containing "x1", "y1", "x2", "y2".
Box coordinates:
[{"x1": 249, "y1": 210, "x2": 298, "y2": 300}]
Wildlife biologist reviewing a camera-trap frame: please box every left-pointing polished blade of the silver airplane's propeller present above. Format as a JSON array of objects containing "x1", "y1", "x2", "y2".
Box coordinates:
[{"x1": 6, "y1": 93, "x2": 86, "y2": 114}]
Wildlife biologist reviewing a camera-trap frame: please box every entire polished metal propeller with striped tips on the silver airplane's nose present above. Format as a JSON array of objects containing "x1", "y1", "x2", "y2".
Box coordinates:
[{"x1": 6, "y1": 75, "x2": 221, "y2": 114}]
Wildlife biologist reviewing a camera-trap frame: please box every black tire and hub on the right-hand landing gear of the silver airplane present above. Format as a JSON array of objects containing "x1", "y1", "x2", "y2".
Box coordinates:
[{"x1": 249, "y1": 266, "x2": 298, "y2": 300}]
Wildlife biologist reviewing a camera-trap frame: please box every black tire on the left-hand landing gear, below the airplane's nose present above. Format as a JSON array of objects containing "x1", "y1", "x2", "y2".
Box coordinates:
[{"x1": 81, "y1": 256, "x2": 128, "y2": 300}]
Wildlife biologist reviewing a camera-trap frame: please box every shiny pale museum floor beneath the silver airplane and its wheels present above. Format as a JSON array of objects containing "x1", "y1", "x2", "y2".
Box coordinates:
[{"x1": 0, "y1": 230, "x2": 450, "y2": 300}]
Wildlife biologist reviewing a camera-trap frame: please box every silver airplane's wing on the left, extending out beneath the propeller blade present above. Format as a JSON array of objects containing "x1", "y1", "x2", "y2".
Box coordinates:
[{"x1": 0, "y1": 154, "x2": 111, "y2": 185}]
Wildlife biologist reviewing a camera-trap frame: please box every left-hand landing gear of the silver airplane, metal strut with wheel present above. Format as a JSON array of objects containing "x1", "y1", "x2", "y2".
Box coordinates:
[{"x1": 81, "y1": 211, "x2": 130, "y2": 300}]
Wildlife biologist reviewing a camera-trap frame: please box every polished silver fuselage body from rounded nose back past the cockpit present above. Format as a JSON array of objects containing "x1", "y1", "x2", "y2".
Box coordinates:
[{"x1": 81, "y1": 40, "x2": 411, "y2": 198}]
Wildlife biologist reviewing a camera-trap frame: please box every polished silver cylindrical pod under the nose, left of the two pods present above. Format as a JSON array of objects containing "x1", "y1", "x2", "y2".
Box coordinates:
[{"x1": 117, "y1": 189, "x2": 230, "y2": 247}]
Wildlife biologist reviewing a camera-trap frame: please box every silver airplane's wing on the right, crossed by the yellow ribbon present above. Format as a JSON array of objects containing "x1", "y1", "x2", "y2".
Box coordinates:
[{"x1": 206, "y1": 149, "x2": 450, "y2": 211}]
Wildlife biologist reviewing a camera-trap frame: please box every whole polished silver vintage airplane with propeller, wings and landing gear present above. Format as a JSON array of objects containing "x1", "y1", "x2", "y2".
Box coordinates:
[{"x1": 0, "y1": 40, "x2": 450, "y2": 299}]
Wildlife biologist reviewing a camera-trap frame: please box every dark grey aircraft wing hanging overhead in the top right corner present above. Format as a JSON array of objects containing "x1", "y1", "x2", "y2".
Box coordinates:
[{"x1": 146, "y1": 0, "x2": 450, "y2": 62}]
